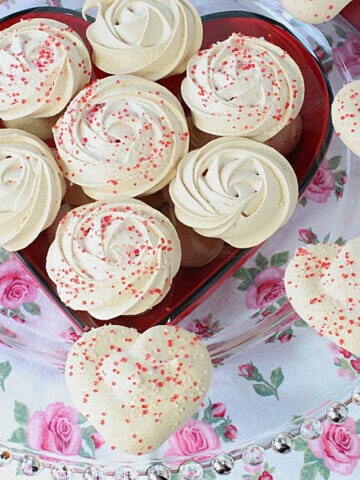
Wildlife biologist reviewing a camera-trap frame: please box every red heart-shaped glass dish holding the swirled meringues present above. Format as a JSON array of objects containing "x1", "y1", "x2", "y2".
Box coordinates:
[{"x1": 0, "y1": 7, "x2": 332, "y2": 338}]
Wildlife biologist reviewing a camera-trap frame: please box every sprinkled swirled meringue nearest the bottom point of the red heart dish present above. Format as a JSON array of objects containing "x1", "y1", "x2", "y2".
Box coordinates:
[{"x1": 46, "y1": 197, "x2": 181, "y2": 320}]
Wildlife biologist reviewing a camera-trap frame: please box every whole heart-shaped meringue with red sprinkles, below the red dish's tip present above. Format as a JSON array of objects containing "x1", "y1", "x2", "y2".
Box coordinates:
[{"x1": 65, "y1": 325, "x2": 212, "y2": 455}]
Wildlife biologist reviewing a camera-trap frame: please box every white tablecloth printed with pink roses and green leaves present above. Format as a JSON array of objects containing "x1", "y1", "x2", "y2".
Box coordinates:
[{"x1": 0, "y1": 0, "x2": 360, "y2": 480}]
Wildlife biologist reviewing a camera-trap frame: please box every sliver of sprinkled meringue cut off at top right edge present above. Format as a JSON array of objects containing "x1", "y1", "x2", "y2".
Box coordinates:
[{"x1": 281, "y1": 0, "x2": 352, "y2": 24}]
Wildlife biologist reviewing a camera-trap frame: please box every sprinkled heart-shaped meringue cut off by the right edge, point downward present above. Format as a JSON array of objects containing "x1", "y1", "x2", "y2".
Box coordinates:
[{"x1": 284, "y1": 237, "x2": 360, "y2": 355}]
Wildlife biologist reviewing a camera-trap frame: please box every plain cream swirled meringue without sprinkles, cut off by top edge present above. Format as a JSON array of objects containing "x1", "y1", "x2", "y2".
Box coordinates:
[{"x1": 82, "y1": 0, "x2": 203, "y2": 80}]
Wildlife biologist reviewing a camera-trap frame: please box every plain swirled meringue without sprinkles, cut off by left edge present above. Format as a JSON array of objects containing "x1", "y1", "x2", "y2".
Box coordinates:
[{"x1": 0, "y1": 128, "x2": 65, "y2": 251}]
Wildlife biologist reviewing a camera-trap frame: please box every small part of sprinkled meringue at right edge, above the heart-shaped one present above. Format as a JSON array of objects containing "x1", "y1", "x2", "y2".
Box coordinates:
[{"x1": 331, "y1": 80, "x2": 360, "y2": 157}]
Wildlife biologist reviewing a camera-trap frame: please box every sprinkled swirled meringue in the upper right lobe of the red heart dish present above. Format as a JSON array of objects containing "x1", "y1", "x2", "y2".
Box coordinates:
[{"x1": 181, "y1": 33, "x2": 304, "y2": 142}]
